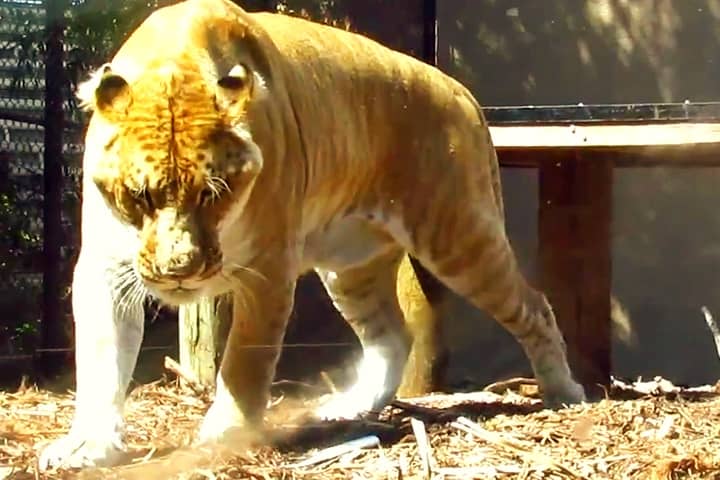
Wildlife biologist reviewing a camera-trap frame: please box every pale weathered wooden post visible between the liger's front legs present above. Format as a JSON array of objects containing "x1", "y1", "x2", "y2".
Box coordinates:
[{"x1": 178, "y1": 295, "x2": 232, "y2": 386}]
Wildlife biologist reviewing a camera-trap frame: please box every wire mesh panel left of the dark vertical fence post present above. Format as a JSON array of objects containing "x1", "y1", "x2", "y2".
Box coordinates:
[{"x1": 0, "y1": 2, "x2": 45, "y2": 376}]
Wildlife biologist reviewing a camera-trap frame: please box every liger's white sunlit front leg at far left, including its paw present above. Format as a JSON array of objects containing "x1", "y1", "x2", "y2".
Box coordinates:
[{"x1": 39, "y1": 255, "x2": 143, "y2": 470}]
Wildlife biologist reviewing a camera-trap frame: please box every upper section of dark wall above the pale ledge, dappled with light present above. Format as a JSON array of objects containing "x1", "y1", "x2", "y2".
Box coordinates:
[{"x1": 437, "y1": 0, "x2": 720, "y2": 105}]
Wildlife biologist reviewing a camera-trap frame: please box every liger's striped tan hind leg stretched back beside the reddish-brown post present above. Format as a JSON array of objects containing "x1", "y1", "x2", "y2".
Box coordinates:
[{"x1": 414, "y1": 201, "x2": 585, "y2": 407}]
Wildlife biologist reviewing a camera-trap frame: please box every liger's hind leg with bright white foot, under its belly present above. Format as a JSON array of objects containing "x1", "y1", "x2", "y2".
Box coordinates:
[{"x1": 317, "y1": 248, "x2": 411, "y2": 419}]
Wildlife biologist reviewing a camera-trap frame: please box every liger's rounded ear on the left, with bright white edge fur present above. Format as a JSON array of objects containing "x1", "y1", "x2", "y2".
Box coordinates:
[{"x1": 77, "y1": 63, "x2": 132, "y2": 114}]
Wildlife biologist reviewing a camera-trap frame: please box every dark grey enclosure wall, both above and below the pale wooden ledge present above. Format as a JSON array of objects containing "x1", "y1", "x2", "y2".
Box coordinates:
[{"x1": 438, "y1": 0, "x2": 720, "y2": 383}]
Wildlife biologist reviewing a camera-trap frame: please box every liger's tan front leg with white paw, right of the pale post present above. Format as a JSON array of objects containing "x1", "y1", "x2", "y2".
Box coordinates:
[{"x1": 198, "y1": 269, "x2": 295, "y2": 442}]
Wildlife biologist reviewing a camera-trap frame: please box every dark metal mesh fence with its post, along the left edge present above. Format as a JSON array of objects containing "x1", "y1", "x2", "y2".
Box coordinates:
[{"x1": 0, "y1": 0, "x2": 81, "y2": 376}]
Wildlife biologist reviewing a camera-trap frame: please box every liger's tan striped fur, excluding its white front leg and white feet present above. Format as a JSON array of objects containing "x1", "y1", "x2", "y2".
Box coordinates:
[{"x1": 83, "y1": 0, "x2": 583, "y2": 438}]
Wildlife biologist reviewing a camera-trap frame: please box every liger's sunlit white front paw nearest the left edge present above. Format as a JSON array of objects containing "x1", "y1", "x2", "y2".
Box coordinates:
[{"x1": 38, "y1": 432, "x2": 127, "y2": 471}]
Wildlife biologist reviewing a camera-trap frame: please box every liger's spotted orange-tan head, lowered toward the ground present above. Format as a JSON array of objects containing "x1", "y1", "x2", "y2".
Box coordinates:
[{"x1": 79, "y1": 60, "x2": 263, "y2": 304}]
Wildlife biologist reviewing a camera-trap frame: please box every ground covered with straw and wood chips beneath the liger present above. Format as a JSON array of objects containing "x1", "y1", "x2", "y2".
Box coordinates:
[{"x1": 0, "y1": 378, "x2": 720, "y2": 480}]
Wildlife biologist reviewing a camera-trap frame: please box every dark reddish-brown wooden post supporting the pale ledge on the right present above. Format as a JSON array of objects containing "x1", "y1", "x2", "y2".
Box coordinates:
[{"x1": 538, "y1": 151, "x2": 613, "y2": 396}]
